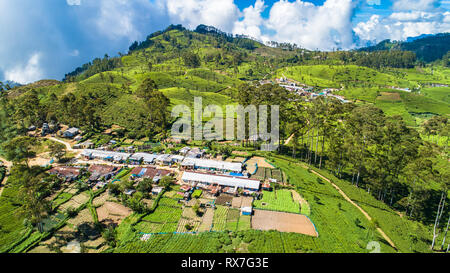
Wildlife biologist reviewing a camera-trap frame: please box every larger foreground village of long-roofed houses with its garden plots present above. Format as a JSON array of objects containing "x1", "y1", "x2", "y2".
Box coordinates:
[{"x1": 16, "y1": 124, "x2": 318, "y2": 252}]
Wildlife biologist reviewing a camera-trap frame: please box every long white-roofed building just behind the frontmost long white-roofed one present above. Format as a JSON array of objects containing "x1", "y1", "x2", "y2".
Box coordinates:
[{"x1": 181, "y1": 157, "x2": 242, "y2": 173}]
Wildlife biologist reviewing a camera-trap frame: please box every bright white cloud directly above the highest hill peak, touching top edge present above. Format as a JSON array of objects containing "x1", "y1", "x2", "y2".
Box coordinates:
[{"x1": 166, "y1": 0, "x2": 240, "y2": 32}]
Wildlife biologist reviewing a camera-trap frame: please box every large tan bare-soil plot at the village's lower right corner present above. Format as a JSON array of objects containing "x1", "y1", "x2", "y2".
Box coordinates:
[{"x1": 252, "y1": 210, "x2": 318, "y2": 237}]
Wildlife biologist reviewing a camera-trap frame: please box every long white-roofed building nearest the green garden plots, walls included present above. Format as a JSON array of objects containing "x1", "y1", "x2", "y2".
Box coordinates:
[{"x1": 181, "y1": 171, "x2": 261, "y2": 192}]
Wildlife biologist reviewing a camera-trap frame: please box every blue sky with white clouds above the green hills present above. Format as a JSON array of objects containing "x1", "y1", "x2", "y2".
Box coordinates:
[{"x1": 0, "y1": 0, "x2": 450, "y2": 84}]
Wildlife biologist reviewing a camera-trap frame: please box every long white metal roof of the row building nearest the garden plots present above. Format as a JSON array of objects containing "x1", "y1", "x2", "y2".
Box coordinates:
[{"x1": 181, "y1": 172, "x2": 260, "y2": 190}]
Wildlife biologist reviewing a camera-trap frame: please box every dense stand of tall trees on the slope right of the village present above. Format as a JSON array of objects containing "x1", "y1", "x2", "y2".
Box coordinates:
[{"x1": 280, "y1": 94, "x2": 450, "y2": 226}]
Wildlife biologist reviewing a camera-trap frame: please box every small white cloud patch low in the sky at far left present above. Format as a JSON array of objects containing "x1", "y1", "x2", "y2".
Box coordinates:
[{"x1": 5, "y1": 53, "x2": 44, "y2": 84}]
